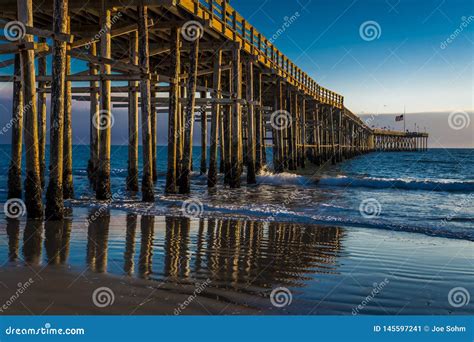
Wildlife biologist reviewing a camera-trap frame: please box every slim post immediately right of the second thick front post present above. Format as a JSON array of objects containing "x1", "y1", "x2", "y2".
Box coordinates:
[{"x1": 63, "y1": 16, "x2": 74, "y2": 199}]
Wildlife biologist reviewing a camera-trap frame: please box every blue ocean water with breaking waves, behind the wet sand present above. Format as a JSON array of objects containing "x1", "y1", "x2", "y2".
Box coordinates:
[{"x1": 0, "y1": 145, "x2": 474, "y2": 241}]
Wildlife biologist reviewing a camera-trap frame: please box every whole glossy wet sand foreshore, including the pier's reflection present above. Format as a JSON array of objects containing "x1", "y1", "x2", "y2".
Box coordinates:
[{"x1": 0, "y1": 209, "x2": 474, "y2": 315}]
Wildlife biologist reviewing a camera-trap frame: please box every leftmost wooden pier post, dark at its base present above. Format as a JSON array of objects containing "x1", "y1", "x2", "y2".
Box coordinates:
[{"x1": 8, "y1": 55, "x2": 24, "y2": 199}]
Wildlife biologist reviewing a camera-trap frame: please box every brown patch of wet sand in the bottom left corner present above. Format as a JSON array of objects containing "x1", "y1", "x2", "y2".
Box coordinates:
[{"x1": 0, "y1": 267, "x2": 259, "y2": 315}]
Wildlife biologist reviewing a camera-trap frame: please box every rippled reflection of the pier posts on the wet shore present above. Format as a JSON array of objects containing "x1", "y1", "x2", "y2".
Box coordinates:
[{"x1": 0, "y1": 209, "x2": 343, "y2": 292}]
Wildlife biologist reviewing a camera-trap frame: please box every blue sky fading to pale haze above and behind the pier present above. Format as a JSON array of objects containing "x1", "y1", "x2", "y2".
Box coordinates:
[{"x1": 0, "y1": 0, "x2": 474, "y2": 147}]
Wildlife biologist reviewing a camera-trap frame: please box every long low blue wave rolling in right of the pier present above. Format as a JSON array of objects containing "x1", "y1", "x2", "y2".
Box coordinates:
[{"x1": 318, "y1": 176, "x2": 474, "y2": 192}]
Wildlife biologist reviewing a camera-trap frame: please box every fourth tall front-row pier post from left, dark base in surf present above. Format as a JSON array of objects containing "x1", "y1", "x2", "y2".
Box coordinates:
[{"x1": 138, "y1": 0, "x2": 155, "y2": 202}]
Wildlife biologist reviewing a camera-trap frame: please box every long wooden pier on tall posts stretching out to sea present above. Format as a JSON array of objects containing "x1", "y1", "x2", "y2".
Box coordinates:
[{"x1": 0, "y1": 0, "x2": 428, "y2": 219}]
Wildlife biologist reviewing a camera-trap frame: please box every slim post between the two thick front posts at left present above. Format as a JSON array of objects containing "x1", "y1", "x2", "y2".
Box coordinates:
[{"x1": 38, "y1": 38, "x2": 47, "y2": 189}]
